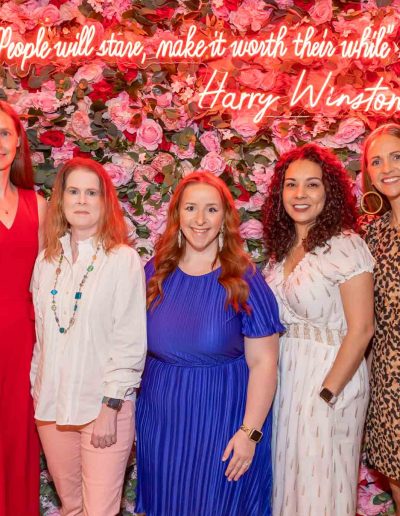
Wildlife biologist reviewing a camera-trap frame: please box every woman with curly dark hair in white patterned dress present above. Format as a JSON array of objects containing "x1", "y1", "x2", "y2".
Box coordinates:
[{"x1": 264, "y1": 144, "x2": 374, "y2": 516}]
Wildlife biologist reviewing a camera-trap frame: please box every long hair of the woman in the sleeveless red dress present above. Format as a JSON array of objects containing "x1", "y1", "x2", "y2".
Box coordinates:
[{"x1": 0, "y1": 100, "x2": 33, "y2": 190}]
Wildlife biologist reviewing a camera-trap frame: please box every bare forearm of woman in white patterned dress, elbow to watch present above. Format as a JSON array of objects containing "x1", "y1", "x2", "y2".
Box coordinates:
[{"x1": 323, "y1": 329, "x2": 372, "y2": 396}]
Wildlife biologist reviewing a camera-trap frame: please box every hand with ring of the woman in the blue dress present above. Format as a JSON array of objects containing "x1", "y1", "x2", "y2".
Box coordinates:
[{"x1": 222, "y1": 430, "x2": 256, "y2": 482}]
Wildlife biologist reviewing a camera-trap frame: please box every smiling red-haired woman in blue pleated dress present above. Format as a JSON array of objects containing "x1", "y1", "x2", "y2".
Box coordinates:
[{"x1": 136, "y1": 172, "x2": 284, "y2": 516}]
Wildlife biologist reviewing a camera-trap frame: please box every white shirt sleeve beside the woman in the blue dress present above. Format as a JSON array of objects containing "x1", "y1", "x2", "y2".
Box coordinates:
[{"x1": 104, "y1": 246, "x2": 147, "y2": 399}]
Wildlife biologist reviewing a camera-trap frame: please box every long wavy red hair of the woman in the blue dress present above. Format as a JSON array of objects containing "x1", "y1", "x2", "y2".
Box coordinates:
[{"x1": 147, "y1": 171, "x2": 254, "y2": 312}]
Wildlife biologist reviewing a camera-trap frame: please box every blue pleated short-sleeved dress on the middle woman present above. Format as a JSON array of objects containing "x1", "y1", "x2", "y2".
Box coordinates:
[{"x1": 136, "y1": 262, "x2": 284, "y2": 516}]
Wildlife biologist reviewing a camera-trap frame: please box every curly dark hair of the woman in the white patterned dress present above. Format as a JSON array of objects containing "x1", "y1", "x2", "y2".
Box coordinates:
[{"x1": 263, "y1": 143, "x2": 357, "y2": 262}]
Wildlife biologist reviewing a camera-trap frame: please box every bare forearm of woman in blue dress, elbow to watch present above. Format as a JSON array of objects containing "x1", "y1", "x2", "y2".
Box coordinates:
[{"x1": 243, "y1": 360, "x2": 277, "y2": 430}]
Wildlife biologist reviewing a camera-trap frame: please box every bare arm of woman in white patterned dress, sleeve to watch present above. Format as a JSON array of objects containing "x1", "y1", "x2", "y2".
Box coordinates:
[{"x1": 323, "y1": 272, "x2": 374, "y2": 396}]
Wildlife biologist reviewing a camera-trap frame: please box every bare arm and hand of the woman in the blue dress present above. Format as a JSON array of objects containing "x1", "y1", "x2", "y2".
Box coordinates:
[{"x1": 222, "y1": 334, "x2": 278, "y2": 481}]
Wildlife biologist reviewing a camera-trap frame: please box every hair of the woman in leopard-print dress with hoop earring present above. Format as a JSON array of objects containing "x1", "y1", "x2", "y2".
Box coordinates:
[{"x1": 361, "y1": 124, "x2": 400, "y2": 215}]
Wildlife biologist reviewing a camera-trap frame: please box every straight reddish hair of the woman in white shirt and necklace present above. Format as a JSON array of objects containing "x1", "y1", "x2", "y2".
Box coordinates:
[{"x1": 45, "y1": 158, "x2": 130, "y2": 260}]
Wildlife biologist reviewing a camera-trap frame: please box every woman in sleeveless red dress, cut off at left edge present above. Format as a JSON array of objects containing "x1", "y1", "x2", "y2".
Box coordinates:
[{"x1": 0, "y1": 101, "x2": 46, "y2": 516}]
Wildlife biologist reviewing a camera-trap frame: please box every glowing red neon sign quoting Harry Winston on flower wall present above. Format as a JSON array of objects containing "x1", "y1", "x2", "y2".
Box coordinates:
[{"x1": 0, "y1": 24, "x2": 400, "y2": 123}]
